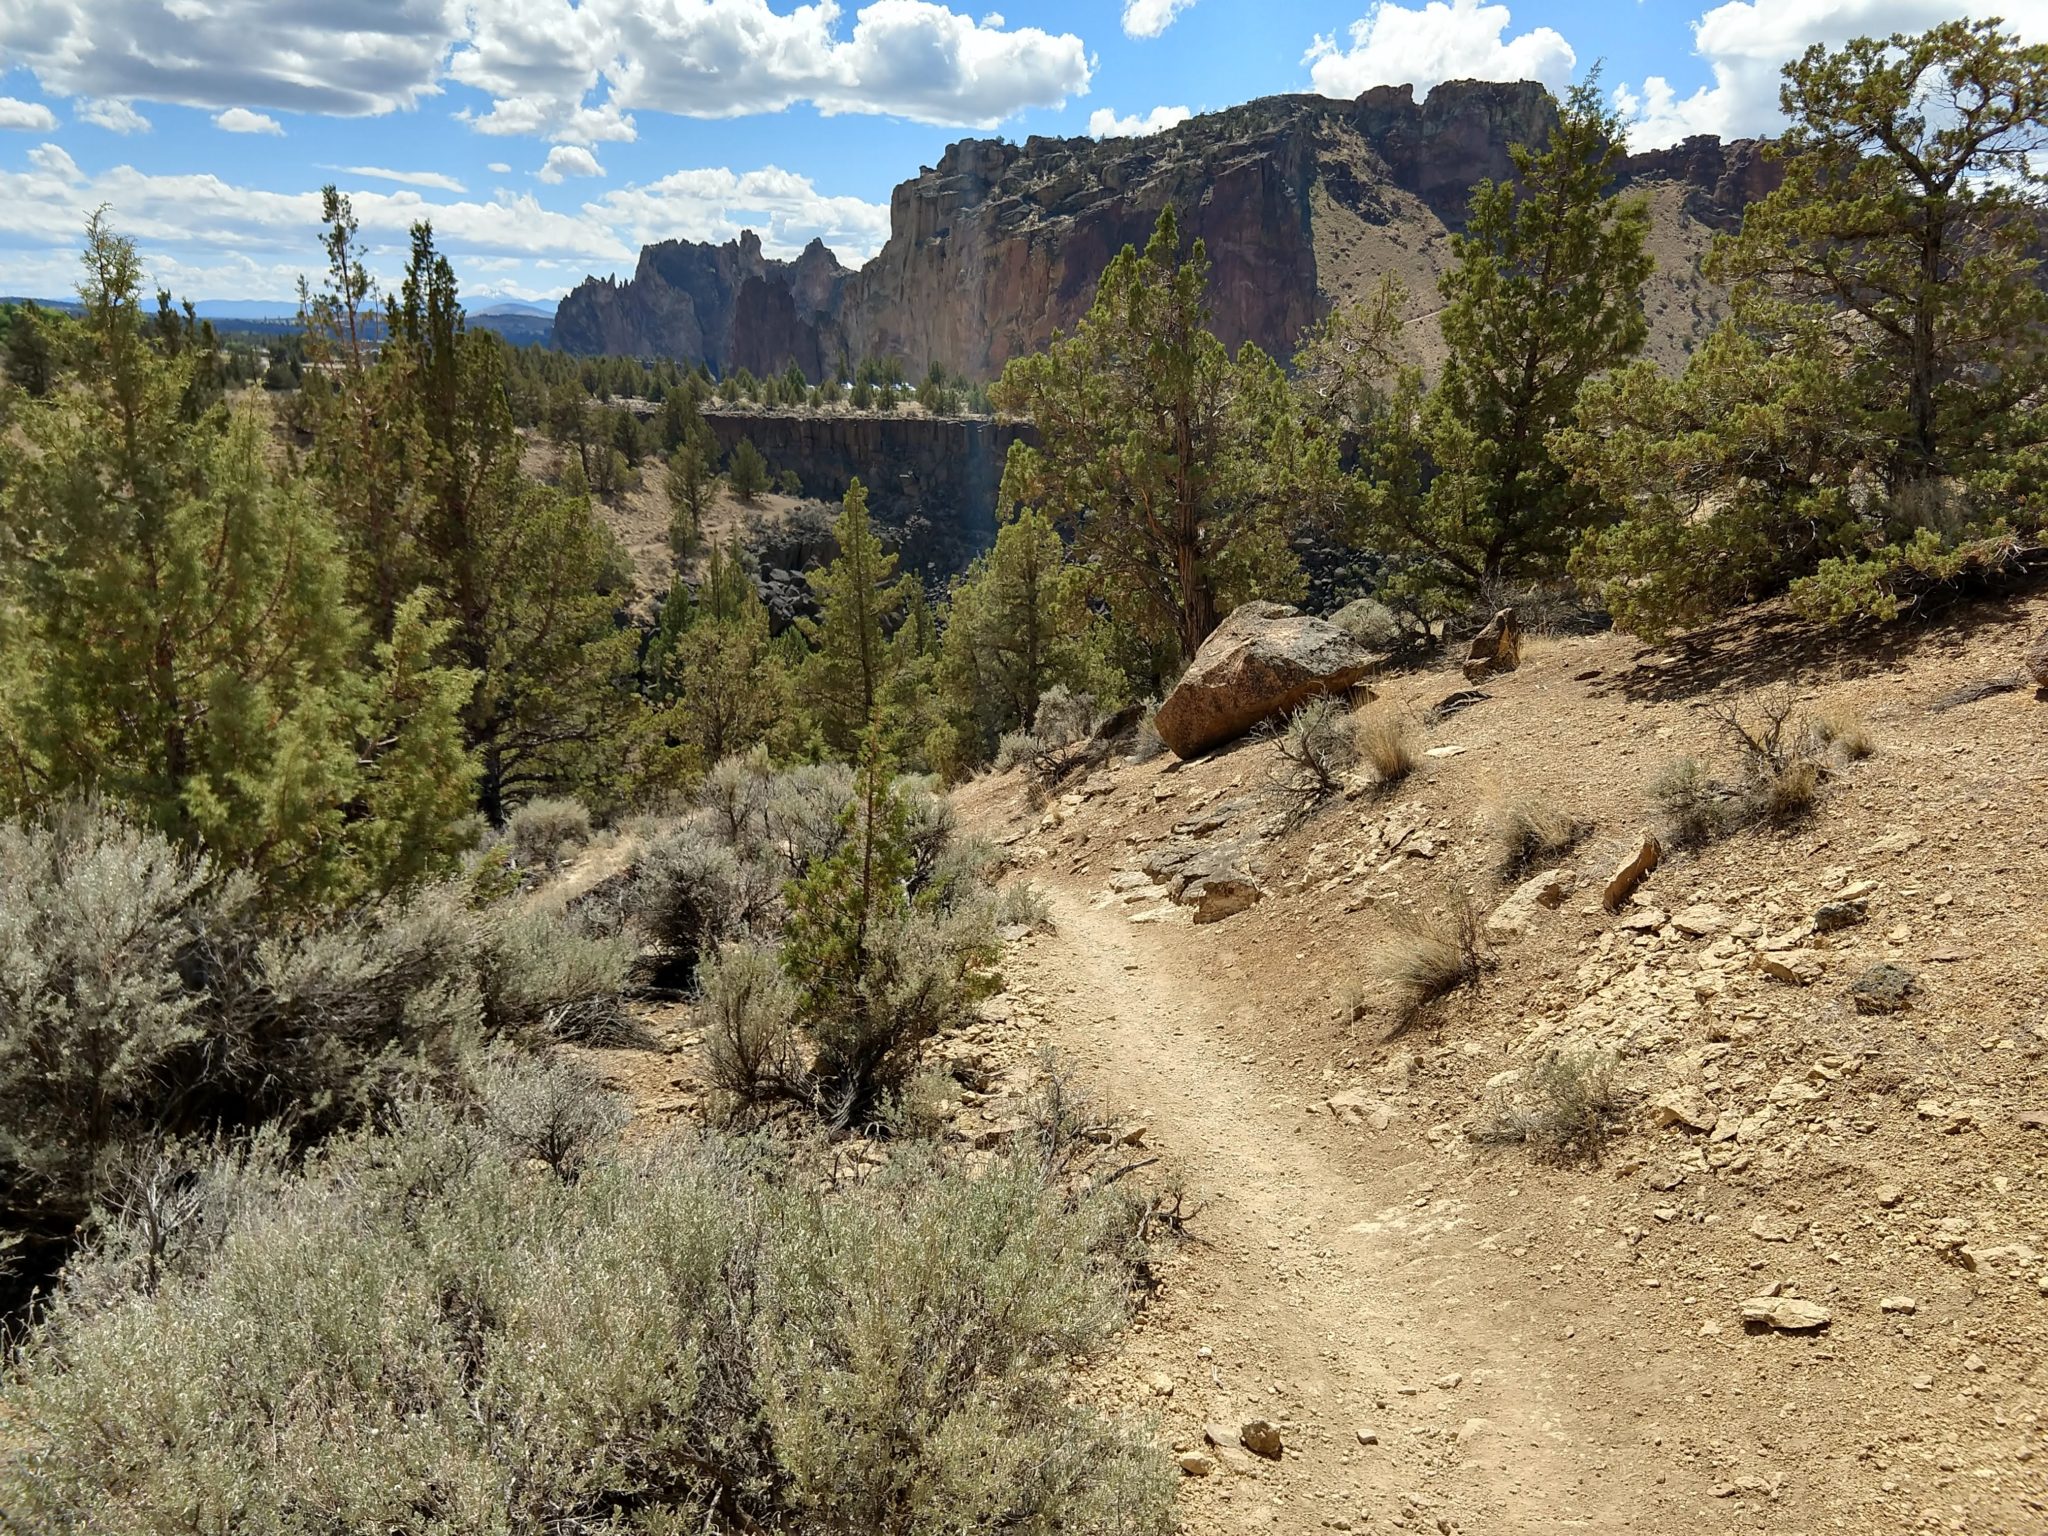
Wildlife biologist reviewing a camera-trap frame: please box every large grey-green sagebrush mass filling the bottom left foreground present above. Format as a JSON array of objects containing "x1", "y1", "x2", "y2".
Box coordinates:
[{"x1": 0, "y1": 1097, "x2": 1174, "y2": 1536}]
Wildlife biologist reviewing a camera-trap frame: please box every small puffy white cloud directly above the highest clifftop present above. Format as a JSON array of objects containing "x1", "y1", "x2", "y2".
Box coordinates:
[{"x1": 1303, "y1": 0, "x2": 1579, "y2": 96}]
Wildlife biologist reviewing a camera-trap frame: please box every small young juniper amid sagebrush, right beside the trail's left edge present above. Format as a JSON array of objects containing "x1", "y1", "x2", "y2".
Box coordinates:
[{"x1": 782, "y1": 733, "x2": 995, "y2": 1126}]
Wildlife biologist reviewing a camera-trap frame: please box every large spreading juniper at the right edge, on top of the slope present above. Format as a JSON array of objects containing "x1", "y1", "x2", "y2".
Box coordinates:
[{"x1": 1561, "y1": 20, "x2": 2048, "y2": 637}]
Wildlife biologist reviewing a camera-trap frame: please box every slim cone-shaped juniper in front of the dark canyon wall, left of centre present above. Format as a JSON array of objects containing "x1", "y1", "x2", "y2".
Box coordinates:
[{"x1": 799, "y1": 479, "x2": 915, "y2": 758}]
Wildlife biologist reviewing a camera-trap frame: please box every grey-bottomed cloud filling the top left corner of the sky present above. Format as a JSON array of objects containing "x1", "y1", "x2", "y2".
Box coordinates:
[{"x1": 0, "y1": 0, "x2": 460, "y2": 117}]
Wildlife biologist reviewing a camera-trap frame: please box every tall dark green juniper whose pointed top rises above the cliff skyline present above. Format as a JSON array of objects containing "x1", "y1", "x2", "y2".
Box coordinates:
[{"x1": 1376, "y1": 82, "x2": 1655, "y2": 602}]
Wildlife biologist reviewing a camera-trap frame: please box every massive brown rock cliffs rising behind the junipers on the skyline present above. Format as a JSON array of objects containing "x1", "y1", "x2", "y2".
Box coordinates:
[{"x1": 555, "y1": 82, "x2": 1772, "y2": 379}]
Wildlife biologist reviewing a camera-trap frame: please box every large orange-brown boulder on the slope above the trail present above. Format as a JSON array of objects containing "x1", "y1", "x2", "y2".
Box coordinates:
[{"x1": 1153, "y1": 602, "x2": 1376, "y2": 758}]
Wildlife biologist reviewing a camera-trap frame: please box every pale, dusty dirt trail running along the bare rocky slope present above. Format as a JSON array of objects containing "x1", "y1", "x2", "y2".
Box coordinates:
[{"x1": 1006, "y1": 887, "x2": 1696, "y2": 1536}]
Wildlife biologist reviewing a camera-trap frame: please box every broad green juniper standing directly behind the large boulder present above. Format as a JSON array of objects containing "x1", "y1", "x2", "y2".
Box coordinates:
[{"x1": 993, "y1": 209, "x2": 1317, "y2": 674}]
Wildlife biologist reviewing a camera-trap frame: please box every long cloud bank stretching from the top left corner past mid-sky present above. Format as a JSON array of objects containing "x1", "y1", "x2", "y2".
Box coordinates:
[{"x1": 0, "y1": 0, "x2": 1089, "y2": 135}]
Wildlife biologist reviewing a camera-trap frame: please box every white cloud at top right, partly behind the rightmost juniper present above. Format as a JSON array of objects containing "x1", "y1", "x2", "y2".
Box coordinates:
[{"x1": 1614, "y1": 0, "x2": 2048, "y2": 150}]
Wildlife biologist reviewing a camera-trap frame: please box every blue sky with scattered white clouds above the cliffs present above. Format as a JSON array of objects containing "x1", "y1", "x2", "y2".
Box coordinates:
[{"x1": 0, "y1": 0, "x2": 2023, "y2": 299}]
